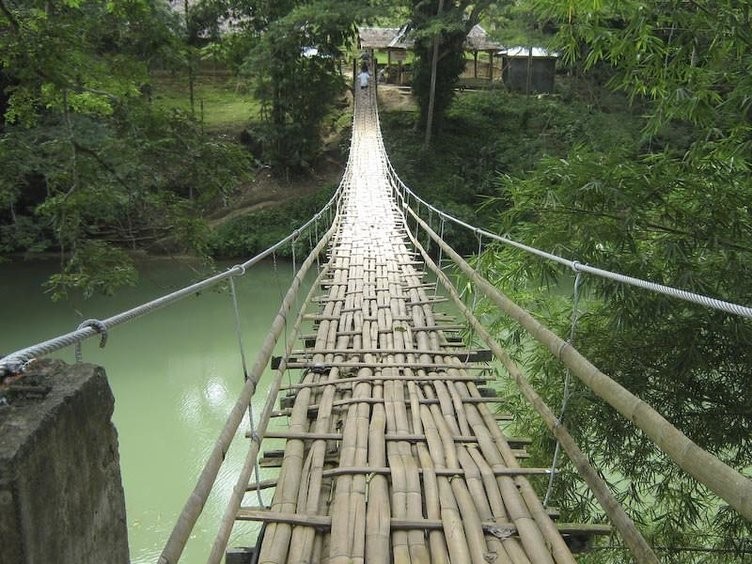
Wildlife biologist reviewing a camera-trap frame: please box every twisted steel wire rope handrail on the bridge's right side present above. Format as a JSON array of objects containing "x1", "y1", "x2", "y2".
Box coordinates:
[{"x1": 388, "y1": 156, "x2": 752, "y2": 319}]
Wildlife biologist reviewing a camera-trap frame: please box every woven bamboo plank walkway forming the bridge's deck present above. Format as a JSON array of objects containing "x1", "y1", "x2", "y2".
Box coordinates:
[{"x1": 242, "y1": 90, "x2": 602, "y2": 564}]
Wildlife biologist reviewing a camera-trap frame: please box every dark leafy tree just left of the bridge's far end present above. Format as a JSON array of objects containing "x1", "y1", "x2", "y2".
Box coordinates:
[{"x1": 197, "y1": 0, "x2": 372, "y2": 170}]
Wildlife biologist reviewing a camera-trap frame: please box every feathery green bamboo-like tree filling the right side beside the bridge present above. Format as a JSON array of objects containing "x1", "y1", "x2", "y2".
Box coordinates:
[{"x1": 482, "y1": 0, "x2": 752, "y2": 562}]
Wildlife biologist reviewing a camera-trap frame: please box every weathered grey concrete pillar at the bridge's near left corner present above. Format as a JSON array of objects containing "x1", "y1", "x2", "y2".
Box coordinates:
[{"x1": 0, "y1": 360, "x2": 129, "y2": 564}]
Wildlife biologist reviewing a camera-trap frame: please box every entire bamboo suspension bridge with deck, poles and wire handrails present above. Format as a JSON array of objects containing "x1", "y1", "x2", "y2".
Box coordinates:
[{"x1": 0, "y1": 81, "x2": 752, "y2": 564}]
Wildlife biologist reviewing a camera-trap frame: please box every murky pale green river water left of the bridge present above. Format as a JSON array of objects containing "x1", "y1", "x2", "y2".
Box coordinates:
[{"x1": 0, "y1": 259, "x2": 306, "y2": 564}]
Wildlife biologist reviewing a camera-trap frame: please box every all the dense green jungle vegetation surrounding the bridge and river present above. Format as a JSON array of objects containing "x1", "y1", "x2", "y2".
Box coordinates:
[{"x1": 0, "y1": 0, "x2": 752, "y2": 562}]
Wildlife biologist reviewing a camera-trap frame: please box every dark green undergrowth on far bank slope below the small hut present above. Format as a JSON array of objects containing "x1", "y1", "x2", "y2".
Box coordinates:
[{"x1": 381, "y1": 86, "x2": 640, "y2": 253}]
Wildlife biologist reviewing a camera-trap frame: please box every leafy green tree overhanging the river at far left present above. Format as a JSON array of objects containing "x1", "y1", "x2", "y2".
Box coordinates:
[{"x1": 0, "y1": 0, "x2": 253, "y2": 295}]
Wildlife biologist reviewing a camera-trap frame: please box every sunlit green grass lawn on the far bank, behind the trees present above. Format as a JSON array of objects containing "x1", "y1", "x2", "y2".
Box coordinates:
[{"x1": 152, "y1": 74, "x2": 260, "y2": 131}]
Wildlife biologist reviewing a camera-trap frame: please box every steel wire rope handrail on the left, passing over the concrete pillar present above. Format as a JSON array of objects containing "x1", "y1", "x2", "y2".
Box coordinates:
[{"x1": 0, "y1": 185, "x2": 342, "y2": 377}]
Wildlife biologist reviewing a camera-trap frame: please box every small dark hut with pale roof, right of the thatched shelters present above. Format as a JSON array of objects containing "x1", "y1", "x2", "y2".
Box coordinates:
[{"x1": 499, "y1": 47, "x2": 557, "y2": 94}]
